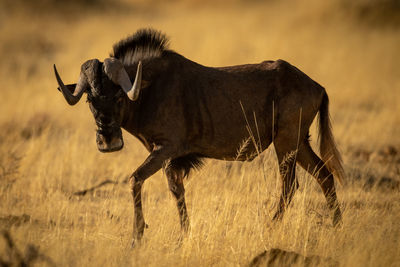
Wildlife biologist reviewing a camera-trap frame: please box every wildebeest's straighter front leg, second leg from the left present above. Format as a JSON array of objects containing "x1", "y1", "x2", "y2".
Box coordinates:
[{"x1": 165, "y1": 166, "x2": 190, "y2": 232}]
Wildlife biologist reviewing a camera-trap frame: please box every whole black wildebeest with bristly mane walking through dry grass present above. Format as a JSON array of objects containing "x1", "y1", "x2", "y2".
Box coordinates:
[{"x1": 54, "y1": 29, "x2": 344, "y2": 245}]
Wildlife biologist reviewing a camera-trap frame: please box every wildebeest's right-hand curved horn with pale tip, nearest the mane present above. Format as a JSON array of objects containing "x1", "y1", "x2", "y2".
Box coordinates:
[{"x1": 104, "y1": 58, "x2": 142, "y2": 101}]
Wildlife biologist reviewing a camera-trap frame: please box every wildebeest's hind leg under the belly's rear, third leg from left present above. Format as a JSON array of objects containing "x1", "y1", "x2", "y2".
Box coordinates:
[{"x1": 273, "y1": 138, "x2": 299, "y2": 221}]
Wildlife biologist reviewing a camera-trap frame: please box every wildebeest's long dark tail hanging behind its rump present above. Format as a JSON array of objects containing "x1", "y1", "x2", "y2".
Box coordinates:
[{"x1": 319, "y1": 91, "x2": 345, "y2": 185}]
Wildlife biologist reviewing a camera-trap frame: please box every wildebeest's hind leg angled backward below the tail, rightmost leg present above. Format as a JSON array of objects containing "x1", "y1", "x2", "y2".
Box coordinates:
[{"x1": 297, "y1": 140, "x2": 342, "y2": 226}]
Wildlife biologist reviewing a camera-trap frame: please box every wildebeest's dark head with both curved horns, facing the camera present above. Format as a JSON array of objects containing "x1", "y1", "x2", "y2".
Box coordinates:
[{"x1": 54, "y1": 57, "x2": 142, "y2": 152}]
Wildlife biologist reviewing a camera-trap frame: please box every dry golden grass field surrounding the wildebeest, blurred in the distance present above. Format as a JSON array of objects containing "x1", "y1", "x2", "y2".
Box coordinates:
[{"x1": 0, "y1": 0, "x2": 400, "y2": 266}]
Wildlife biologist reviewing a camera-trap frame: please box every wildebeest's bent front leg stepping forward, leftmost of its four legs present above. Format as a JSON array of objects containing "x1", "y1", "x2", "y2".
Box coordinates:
[{"x1": 130, "y1": 147, "x2": 170, "y2": 246}]
